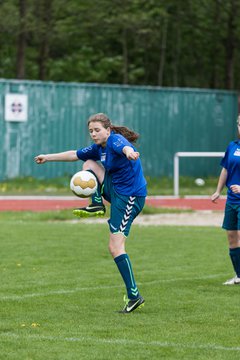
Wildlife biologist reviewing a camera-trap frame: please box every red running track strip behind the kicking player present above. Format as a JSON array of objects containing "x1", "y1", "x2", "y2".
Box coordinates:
[{"x1": 0, "y1": 196, "x2": 226, "y2": 211}]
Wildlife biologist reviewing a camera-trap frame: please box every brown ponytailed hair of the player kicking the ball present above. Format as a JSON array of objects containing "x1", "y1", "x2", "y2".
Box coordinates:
[{"x1": 88, "y1": 113, "x2": 139, "y2": 143}]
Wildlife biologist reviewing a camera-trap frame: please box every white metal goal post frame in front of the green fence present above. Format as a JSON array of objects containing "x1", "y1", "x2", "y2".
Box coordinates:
[{"x1": 173, "y1": 151, "x2": 224, "y2": 196}]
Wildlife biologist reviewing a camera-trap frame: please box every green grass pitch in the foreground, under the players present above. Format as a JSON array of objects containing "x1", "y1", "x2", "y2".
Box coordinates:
[{"x1": 0, "y1": 212, "x2": 240, "y2": 360}]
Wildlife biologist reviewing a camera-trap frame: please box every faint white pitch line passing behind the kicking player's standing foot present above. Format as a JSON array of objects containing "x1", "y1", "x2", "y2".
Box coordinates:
[{"x1": 0, "y1": 273, "x2": 225, "y2": 301}]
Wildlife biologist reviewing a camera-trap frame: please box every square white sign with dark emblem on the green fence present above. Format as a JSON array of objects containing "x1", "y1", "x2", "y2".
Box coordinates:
[{"x1": 5, "y1": 94, "x2": 28, "y2": 121}]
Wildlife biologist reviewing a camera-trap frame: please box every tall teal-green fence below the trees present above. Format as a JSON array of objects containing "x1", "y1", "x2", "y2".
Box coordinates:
[{"x1": 0, "y1": 80, "x2": 238, "y2": 180}]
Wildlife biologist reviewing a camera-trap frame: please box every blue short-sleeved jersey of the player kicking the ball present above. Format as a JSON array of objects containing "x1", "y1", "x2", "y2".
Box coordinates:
[{"x1": 77, "y1": 132, "x2": 147, "y2": 196}]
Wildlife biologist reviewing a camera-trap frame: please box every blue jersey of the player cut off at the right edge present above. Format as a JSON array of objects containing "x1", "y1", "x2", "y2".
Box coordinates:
[{"x1": 221, "y1": 140, "x2": 240, "y2": 204}]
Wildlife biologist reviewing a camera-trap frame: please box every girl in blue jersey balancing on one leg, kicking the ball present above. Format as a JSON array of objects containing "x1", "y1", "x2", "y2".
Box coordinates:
[{"x1": 35, "y1": 113, "x2": 147, "y2": 314}]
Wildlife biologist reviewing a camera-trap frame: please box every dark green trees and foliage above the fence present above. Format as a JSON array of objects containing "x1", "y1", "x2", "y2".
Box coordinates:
[{"x1": 0, "y1": 0, "x2": 240, "y2": 89}]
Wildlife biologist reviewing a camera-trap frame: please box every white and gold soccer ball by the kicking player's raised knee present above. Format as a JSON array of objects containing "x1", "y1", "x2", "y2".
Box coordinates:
[{"x1": 70, "y1": 170, "x2": 98, "y2": 198}]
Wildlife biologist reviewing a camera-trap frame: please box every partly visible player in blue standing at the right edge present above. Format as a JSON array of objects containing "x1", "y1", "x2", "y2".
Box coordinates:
[{"x1": 212, "y1": 116, "x2": 240, "y2": 285}]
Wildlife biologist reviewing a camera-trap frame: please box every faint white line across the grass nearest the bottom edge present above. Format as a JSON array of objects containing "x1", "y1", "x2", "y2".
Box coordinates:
[{"x1": 0, "y1": 333, "x2": 240, "y2": 352}]
